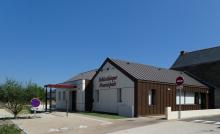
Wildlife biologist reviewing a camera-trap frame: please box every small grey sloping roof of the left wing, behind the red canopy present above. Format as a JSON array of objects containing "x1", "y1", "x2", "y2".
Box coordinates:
[{"x1": 64, "y1": 69, "x2": 97, "y2": 83}]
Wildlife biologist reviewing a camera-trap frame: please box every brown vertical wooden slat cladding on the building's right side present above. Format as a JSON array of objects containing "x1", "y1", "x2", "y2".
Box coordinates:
[{"x1": 136, "y1": 81, "x2": 208, "y2": 116}]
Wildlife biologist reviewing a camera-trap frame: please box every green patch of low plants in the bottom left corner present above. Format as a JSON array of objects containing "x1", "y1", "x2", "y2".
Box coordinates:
[{"x1": 0, "y1": 125, "x2": 21, "y2": 134}]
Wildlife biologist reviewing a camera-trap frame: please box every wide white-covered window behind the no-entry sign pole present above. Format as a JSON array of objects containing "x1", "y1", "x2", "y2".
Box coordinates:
[{"x1": 176, "y1": 90, "x2": 195, "y2": 105}]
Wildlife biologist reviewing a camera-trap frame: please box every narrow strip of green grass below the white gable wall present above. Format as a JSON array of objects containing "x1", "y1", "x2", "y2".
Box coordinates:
[{"x1": 79, "y1": 112, "x2": 127, "y2": 119}]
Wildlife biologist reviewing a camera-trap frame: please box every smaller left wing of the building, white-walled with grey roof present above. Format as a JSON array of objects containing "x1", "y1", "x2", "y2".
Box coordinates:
[{"x1": 56, "y1": 70, "x2": 96, "y2": 111}]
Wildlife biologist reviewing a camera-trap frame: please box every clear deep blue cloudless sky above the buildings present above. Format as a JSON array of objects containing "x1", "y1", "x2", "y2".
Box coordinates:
[{"x1": 0, "y1": 0, "x2": 220, "y2": 85}]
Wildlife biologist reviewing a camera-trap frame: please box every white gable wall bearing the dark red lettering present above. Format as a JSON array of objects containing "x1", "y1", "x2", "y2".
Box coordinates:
[{"x1": 93, "y1": 63, "x2": 134, "y2": 117}]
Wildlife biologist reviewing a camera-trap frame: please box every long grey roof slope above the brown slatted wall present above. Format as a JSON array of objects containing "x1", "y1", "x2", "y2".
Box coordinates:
[{"x1": 110, "y1": 59, "x2": 205, "y2": 87}]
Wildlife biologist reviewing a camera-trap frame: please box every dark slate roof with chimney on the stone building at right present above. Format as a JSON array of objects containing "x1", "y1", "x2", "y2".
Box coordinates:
[{"x1": 171, "y1": 46, "x2": 220, "y2": 68}]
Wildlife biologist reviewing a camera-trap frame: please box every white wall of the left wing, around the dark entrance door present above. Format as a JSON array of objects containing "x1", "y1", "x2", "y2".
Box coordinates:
[{"x1": 56, "y1": 80, "x2": 85, "y2": 111}]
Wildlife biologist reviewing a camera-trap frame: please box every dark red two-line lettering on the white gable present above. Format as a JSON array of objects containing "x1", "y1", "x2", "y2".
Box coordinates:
[{"x1": 99, "y1": 76, "x2": 118, "y2": 88}]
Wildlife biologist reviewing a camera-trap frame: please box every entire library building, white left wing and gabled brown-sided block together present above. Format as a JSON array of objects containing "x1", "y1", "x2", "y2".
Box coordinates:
[{"x1": 50, "y1": 58, "x2": 211, "y2": 117}]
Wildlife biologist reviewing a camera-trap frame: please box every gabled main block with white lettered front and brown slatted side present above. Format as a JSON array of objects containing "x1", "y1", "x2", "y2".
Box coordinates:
[{"x1": 92, "y1": 58, "x2": 210, "y2": 117}]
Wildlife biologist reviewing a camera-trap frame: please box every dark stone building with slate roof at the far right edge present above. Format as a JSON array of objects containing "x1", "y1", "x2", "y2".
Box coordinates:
[{"x1": 171, "y1": 46, "x2": 220, "y2": 108}]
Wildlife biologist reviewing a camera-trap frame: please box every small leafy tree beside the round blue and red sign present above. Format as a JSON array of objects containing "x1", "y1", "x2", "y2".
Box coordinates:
[{"x1": 0, "y1": 79, "x2": 27, "y2": 118}]
